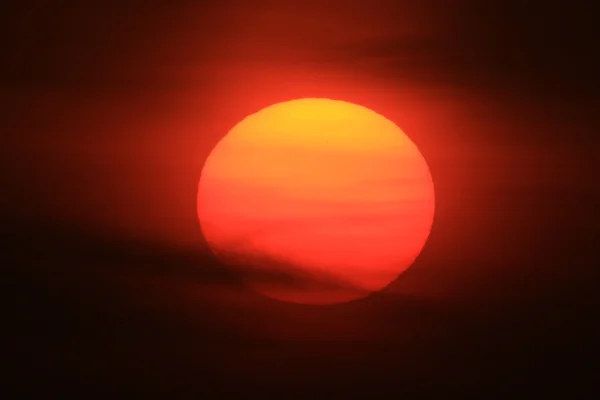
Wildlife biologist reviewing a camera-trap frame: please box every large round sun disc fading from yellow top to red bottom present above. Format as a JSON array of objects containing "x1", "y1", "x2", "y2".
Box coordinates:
[{"x1": 197, "y1": 99, "x2": 435, "y2": 304}]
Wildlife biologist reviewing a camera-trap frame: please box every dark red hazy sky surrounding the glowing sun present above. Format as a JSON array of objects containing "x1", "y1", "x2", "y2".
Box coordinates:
[{"x1": 0, "y1": 0, "x2": 599, "y2": 396}]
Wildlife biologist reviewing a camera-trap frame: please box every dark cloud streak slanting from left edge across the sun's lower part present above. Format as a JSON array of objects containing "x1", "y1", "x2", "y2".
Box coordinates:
[{"x1": 1, "y1": 212, "x2": 376, "y2": 291}]
